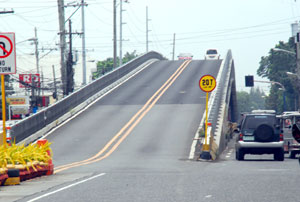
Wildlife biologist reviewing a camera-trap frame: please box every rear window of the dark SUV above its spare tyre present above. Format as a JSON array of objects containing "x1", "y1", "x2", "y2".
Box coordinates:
[{"x1": 243, "y1": 115, "x2": 276, "y2": 129}]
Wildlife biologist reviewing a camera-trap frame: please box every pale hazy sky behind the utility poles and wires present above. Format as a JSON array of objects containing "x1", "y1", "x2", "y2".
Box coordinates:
[{"x1": 0, "y1": 0, "x2": 300, "y2": 92}]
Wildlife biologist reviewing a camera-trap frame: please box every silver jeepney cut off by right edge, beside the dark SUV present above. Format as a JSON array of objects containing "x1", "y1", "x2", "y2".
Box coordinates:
[{"x1": 281, "y1": 111, "x2": 300, "y2": 159}]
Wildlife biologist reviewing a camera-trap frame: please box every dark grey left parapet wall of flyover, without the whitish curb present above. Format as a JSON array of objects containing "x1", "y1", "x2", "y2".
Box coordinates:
[{"x1": 10, "y1": 51, "x2": 164, "y2": 143}]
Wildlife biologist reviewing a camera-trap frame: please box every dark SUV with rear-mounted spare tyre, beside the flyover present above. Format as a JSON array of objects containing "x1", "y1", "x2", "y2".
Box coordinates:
[{"x1": 235, "y1": 113, "x2": 284, "y2": 161}]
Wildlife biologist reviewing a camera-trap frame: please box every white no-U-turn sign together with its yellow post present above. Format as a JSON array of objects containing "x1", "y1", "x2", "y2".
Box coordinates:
[{"x1": 0, "y1": 32, "x2": 16, "y2": 145}]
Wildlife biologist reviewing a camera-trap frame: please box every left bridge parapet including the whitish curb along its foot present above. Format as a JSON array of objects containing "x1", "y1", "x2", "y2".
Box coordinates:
[{"x1": 10, "y1": 51, "x2": 164, "y2": 144}]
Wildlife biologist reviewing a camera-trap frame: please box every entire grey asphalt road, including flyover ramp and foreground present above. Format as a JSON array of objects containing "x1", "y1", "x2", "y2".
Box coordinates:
[{"x1": 0, "y1": 61, "x2": 300, "y2": 202}]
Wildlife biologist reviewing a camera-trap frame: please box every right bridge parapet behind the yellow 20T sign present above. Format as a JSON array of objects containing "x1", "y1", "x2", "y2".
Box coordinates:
[{"x1": 189, "y1": 50, "x2": 237, "y2": 160}]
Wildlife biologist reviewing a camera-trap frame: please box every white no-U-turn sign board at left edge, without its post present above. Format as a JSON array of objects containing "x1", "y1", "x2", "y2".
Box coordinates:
[{"x1": 0, "y1": 32, "x2": 16, "y2": 74}]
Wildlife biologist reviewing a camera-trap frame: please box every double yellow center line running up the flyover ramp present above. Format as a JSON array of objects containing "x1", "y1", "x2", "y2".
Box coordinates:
[{"x1": 54, "y1": 61, "x2": 191, "y2": 173}]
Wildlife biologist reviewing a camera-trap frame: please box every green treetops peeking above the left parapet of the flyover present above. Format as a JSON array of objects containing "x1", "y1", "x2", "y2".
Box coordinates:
[{"x1": 93, "y1": 51, "x2": 138, "y2": 79}]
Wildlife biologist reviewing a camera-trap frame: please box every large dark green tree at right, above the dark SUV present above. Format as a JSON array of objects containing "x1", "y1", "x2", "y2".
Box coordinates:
[{"x1": 257, "y1": 37, "x2": 297, "y2": 113}]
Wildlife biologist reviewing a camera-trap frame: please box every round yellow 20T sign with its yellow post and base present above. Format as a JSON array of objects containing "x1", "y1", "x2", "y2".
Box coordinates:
[{"x1": 199, "y1": 75, "x2": 216, "y2": 160}]
